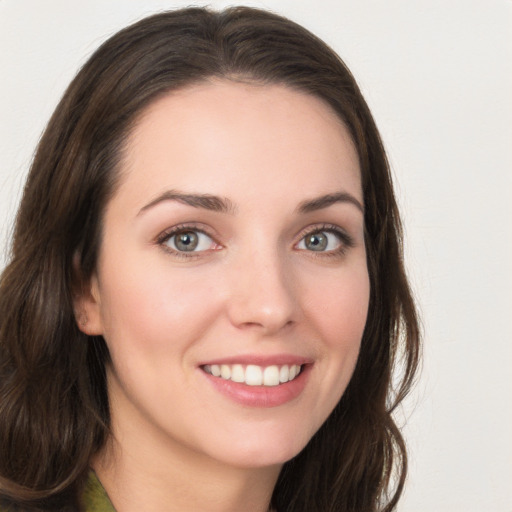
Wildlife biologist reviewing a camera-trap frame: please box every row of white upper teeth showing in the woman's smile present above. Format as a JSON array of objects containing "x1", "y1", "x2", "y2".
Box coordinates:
[{"x1": 201, "y1": 364, "x2": 303, "y2": 387}]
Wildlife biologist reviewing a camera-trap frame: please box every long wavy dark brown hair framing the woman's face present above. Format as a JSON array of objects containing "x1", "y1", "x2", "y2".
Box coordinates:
[{"x1": 0, "y1": 7, "x2": 419, "y2": 512}]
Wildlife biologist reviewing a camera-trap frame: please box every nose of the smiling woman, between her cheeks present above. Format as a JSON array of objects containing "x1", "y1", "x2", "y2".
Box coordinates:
[{"x1": 228, "y1": 245, "x2": 298, "y2": 336}]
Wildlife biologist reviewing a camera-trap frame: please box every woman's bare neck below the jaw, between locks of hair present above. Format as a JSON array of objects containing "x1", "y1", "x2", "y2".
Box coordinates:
[{"x1": 92, "y1": 380, "x2": 281, "y2": 512}]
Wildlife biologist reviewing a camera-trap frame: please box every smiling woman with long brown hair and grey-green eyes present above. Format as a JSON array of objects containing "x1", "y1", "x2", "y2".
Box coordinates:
[{"x1": 0, "y1": 8, "x2": 419, "y2": 512}]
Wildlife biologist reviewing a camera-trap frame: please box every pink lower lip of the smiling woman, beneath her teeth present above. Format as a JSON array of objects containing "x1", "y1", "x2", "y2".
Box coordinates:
[{"x1": 201, "y1": 364, "x2": 311, "y2": 407}]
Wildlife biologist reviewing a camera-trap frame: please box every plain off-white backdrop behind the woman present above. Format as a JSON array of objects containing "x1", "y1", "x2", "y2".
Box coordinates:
[{"x1": 0, "y1": 0, "x2": 512, "y2": 512}]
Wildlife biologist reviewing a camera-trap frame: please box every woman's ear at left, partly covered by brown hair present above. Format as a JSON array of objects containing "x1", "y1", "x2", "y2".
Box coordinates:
[{"x1": 73, "y1": 258, "x2": 103, "y2": 336}]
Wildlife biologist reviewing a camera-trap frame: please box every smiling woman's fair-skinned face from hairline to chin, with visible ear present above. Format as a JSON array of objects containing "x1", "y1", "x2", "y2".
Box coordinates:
[{"x1": 78, "y1": 81, "x2": 369, "y2": 467}]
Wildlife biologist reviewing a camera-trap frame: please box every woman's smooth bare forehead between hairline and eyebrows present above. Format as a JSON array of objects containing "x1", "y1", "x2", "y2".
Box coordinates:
[{"x1": 121, "y1": 80, "x2": 362, "y2": 206}]
